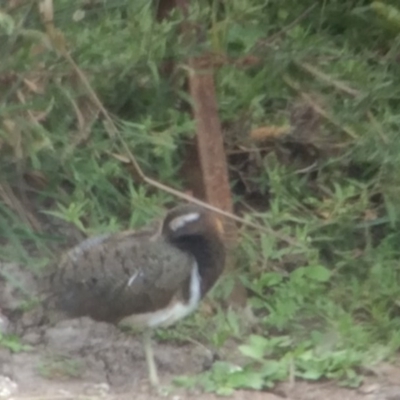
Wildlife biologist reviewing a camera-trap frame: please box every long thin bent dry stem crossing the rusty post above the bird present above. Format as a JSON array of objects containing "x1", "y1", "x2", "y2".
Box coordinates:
[{"x1": 38, "y1": 10, "x2": 304, "y2": 248}]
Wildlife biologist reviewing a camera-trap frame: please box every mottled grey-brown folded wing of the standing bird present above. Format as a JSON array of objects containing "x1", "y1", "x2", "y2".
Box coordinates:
[{"x1": 52, "y1": 232, "x2": 194, "y2": 322}]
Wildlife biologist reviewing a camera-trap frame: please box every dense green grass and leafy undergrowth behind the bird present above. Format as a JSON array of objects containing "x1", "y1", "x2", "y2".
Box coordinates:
[{"x1": 0, "y1": 0, "x2": 400, "y2": 393}]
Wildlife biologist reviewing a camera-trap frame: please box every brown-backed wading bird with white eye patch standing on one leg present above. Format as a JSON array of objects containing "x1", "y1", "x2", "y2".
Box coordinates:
[{"x1": 45, "y1": 204, "x2": 226, "y2": 387}]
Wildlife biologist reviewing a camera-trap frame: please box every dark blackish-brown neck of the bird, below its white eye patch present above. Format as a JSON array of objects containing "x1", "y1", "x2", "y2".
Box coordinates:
[{"x1": 172, "y1": 235, "x2": 225, "y2": 297}]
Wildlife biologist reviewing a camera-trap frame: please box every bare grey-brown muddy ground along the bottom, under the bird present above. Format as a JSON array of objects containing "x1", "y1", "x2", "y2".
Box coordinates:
[{"x1": 0, "y1": 264, "x2": 400, "y2": 400}]
